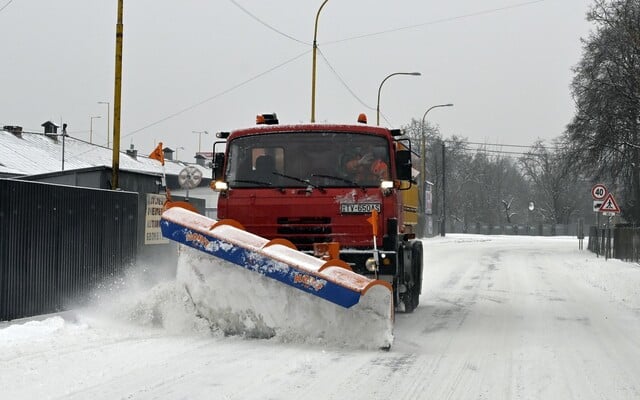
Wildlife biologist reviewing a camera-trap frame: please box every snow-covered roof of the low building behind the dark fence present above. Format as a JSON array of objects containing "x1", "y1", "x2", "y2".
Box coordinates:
[{"x1": 0, "y1": 130, "x2": 210, "y2": 176}]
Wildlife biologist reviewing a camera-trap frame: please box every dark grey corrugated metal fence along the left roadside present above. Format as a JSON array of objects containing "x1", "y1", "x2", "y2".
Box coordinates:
[{"x1": 0, "y1": 179, "x2": 138, "y2": 320}]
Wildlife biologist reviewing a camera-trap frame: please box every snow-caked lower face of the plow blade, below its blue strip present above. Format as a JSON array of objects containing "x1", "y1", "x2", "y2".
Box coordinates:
[{"x1": 176, "y1": 246, "x2": 393, "y2": 348}]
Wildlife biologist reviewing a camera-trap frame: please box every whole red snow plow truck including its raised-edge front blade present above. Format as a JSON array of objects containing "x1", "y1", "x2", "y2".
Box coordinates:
[{"x1": 162, "y1": 114, "x2": 423, "y2": 348}]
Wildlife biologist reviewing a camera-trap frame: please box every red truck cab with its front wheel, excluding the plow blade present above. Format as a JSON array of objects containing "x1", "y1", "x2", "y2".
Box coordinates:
[{"x1": 213, "y1": 114, "x2": 422, "y2": 311}]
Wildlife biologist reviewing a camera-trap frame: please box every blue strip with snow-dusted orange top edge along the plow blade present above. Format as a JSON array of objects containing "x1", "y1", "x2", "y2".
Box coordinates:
[{"x1": 160, "y1": 207, "x2": 393, "y2": 310}]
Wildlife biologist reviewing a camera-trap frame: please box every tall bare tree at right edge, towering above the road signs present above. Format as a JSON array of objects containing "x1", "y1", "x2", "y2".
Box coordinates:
[{"x1": 565, "y1": 0, "x2": 640, "y2": 223}]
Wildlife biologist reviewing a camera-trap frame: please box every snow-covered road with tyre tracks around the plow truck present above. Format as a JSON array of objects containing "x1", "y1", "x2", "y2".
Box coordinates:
[{"x1": 0, "y1": 235, "x2": 640, "y2": 400}]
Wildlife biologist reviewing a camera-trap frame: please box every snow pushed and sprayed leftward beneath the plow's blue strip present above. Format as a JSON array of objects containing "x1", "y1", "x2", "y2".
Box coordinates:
[{"x1": 71, "y1": 246, "x2": 393, "y2": 349}]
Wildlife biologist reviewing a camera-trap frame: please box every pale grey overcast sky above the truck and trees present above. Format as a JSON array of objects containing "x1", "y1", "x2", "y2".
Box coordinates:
[{"x1": 0, "y1": 0, "x2": 592, "y2": 161}]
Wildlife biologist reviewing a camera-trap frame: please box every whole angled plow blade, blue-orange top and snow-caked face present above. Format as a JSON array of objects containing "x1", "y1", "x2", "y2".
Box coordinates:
[{"x1": 161, "y1": 207, "x2": 394, "y2": 348}]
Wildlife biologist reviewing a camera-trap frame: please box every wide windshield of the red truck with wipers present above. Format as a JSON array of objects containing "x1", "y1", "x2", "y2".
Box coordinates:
[{"x1": 226, "y1": 132, "x2": 391, "y2": 188}]
